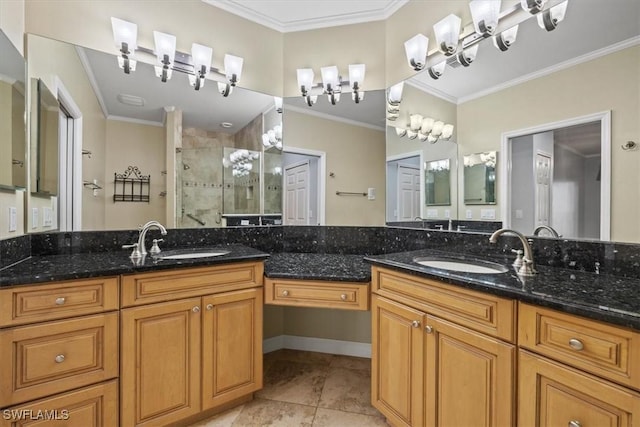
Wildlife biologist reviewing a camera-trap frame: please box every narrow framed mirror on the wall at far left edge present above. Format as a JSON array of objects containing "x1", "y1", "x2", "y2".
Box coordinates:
[{"x1": 0, "y1": 31, "x2": 28, "y2": 189}]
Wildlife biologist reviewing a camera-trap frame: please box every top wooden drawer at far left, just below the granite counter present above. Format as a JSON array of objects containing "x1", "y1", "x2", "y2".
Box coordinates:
[{"x1": 0, "y1": 277, "x2": 118, "y2": 326}]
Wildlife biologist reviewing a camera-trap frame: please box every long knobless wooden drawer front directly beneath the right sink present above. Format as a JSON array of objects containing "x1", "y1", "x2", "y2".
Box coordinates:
[{"x1": 371, "y1": 267, "x2": 516, "y2": 343}]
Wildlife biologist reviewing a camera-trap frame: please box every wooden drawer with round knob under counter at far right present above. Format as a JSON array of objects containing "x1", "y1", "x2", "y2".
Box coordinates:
[{"x1": 518, "y1": 303, "x2": 640, "y2": 390}]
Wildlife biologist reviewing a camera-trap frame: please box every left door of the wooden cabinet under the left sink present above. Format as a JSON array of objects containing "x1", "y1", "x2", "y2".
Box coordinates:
[{"x1": 120, "y1": 298, "x2": 201, "y2": 426}]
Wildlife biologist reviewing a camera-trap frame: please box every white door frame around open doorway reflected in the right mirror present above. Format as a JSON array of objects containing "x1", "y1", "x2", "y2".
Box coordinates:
[{"x1": 498, "y1": 110, "x2": 611, "y2": 241}]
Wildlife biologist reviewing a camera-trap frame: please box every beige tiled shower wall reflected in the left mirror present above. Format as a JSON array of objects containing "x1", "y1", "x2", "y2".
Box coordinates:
[{"x1": 176, "y1": 128, "x2": 235, "y2": 228}]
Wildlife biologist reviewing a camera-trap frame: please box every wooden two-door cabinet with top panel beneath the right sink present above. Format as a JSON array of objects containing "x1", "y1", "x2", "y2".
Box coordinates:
[{"x1": 371, "y1": 267, "x2": 516, "y2": 427}]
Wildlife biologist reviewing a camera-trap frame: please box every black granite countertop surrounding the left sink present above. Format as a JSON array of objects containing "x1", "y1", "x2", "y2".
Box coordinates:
[{"x1": 0, "y1": 244, "x2": 269, "y2": 287}]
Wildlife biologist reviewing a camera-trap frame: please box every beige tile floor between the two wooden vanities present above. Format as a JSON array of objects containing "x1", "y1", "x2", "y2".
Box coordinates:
[{"x1": 191, "y1": 350, "x2": 387, "y2": 427}]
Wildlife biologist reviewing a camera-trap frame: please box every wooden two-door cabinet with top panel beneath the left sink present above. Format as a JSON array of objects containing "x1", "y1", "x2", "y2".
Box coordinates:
[{"x1": 120, "y1": 262, "x2": 263, "y2": 426}]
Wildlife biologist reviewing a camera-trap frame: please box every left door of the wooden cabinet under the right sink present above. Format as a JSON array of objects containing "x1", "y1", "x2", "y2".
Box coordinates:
[{"x1": 371, "y1": 295, "x2": 425, "y2": 426}]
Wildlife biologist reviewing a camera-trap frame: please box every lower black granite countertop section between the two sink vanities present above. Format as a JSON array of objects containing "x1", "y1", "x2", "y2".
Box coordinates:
[{"x1": 264, "y1": 252, "x2": 371, "y2": 282}]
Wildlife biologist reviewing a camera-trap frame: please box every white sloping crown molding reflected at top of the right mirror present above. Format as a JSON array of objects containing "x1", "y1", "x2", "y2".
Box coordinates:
[{"x1": 457, "y1": 36, "x2": 640, "y2": 105}]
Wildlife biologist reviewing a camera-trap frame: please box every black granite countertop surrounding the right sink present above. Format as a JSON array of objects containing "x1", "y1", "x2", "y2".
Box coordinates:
[{"x1": 365, "y1": 250, "x2": 640, "y2": 330}]
